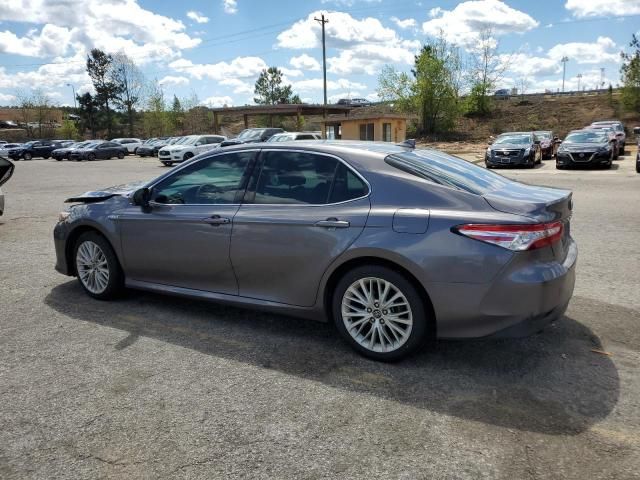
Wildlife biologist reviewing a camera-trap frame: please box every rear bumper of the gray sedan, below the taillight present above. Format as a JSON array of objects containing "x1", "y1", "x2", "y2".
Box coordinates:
[{"x1": 426, "y1": 240, "x2": 578, "y2": 338}]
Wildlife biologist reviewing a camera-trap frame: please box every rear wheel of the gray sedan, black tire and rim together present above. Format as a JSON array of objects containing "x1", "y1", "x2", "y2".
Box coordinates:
[{"x1": 332, "y1": 265, "x2": 429, "y2": 361}]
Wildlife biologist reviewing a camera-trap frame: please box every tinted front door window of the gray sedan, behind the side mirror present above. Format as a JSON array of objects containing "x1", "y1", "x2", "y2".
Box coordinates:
[{"x1": 153, "y1": 152, "x2": 254, "y2": 204}]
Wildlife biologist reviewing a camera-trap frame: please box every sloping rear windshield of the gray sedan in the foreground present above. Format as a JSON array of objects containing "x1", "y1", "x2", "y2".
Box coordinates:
[{"x1": 385, "y1": 150, "x2": 510, "y2": 195}]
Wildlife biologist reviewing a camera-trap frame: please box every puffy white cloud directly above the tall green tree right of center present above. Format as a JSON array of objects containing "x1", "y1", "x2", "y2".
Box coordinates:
[{"x1": 422, "y1": 0, "x2": 539, "y2": 45}]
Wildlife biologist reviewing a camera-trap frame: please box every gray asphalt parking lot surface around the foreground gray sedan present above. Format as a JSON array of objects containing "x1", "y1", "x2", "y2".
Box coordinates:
[{"x1": 0, "y1": 151, "x2": 640, "y2": 480}]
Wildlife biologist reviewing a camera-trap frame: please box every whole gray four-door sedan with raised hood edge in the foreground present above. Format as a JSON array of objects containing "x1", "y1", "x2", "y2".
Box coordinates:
[{"x1": 54, "y1": 141, "x2": 577, "y2": 360}]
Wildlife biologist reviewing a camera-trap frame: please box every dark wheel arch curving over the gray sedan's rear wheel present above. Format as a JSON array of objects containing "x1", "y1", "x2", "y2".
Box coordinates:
[{"x1": 322, "y1": 255, "x2": 437, "y2": 338}]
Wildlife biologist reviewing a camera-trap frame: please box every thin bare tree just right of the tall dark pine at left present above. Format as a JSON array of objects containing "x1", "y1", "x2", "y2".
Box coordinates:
[{"x1": 110, "y1": 52, "x2": 145, "y2": 136}]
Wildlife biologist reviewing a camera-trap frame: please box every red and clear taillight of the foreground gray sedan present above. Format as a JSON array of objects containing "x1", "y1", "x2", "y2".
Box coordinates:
[{"x1": 453, "y1": 222, "x2": 563, "y2": 252}]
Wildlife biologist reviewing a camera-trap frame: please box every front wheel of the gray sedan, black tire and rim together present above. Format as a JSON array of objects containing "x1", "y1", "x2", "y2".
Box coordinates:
[{"x1": 73, "y1": 232, "x2": 124, "y2": 300}]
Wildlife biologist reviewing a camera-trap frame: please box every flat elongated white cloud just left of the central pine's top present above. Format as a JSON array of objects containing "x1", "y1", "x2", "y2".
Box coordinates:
[{"x1": 169, "y1": 57, "x2": 268, "y2": 81}]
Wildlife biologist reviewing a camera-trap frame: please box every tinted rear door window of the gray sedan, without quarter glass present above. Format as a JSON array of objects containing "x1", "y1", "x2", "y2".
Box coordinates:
[{"x1": 254, "y1": 151, "x2": 338, "y2": 205}]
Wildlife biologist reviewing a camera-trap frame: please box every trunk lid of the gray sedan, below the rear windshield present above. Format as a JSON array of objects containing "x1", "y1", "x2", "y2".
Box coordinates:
[{"x1": 483, "y1": 182, "x2": 573, "y2": 261}]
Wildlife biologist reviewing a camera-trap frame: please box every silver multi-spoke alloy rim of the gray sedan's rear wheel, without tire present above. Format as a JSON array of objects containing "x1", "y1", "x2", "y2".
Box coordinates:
[{"x1": 341, "y1": 277, "x2": 413, "y2": 353}]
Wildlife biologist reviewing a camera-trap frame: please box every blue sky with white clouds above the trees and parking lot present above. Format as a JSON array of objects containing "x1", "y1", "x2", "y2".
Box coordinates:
[{"x1": 0, "y1": 0, "x2": 640, "y2": 106}]
